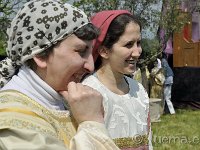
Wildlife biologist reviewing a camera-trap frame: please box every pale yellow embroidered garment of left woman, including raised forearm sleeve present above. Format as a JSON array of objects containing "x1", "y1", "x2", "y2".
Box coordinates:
[{"x1": 0, "y1": 90, "x2": 119, "y2": 150}]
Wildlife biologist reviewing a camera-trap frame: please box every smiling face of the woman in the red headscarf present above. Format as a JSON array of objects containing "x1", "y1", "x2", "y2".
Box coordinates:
[{"x1": 107, "y1": 22, "x2": 142, "y2": 74}]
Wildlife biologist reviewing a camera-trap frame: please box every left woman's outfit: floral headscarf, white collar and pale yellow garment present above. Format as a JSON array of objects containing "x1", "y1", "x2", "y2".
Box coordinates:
[{"x1": 0, "y1": 0, "x2": 118, "y2": 150}]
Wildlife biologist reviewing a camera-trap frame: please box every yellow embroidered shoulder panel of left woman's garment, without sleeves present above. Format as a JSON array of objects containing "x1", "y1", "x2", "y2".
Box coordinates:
[{"x1": 0, "y1": 90, "x2": 76, "y2": 146}]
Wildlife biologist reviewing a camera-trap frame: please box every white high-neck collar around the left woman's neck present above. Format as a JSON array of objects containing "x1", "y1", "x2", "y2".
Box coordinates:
[{"x1": 1, "y1": 66, "x2": 65, "y2": 110}]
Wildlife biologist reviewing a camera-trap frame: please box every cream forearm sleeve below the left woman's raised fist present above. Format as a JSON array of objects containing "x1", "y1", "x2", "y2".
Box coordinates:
[{"x1": 70, "y1": 121, "x2": 119, "y2": 150}]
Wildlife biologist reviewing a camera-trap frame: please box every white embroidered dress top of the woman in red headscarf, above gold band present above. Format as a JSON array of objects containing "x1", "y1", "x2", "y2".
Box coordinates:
[{"x1": 82, "y1": 75, "x2": 149, "y2": 139}]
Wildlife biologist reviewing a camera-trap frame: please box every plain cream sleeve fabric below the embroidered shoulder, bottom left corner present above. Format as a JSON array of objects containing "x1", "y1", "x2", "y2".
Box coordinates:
[{"x1": 0, "y1": 127, "x2": 66, "y2": 150}]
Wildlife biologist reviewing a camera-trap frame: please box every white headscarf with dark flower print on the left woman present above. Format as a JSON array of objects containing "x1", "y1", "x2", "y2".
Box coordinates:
[{"x1": 0, "y1": 0, "x2": 90, "y2": 87}]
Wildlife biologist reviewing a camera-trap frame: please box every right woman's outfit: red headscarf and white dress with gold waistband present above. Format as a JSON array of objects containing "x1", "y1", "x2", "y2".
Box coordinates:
[{"x1": 82, "y1": 10, "x2": 152, "y2": 150}]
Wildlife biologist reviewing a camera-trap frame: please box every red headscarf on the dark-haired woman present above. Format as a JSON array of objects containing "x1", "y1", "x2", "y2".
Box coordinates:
[{"x1": 91, "y1": 10, "x2": 131, "y2": 61}]
